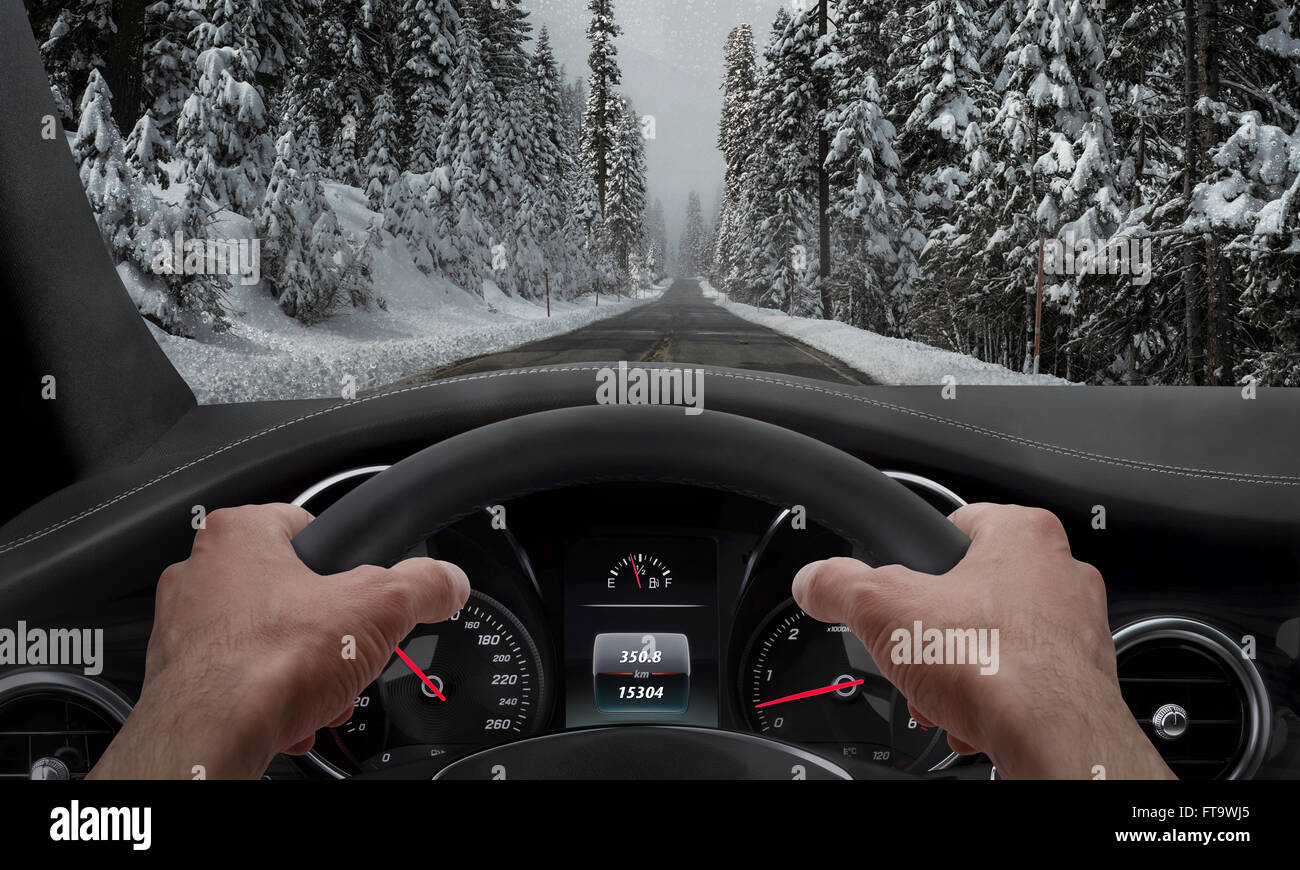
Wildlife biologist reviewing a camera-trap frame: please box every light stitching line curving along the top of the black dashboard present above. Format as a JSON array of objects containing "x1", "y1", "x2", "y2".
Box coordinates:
[{"x1": 0, "y1": 365, "x2": 1300, "y2": 555}]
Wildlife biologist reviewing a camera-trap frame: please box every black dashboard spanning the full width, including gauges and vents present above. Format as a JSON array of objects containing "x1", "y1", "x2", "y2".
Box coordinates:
[{"x1": 0, "y1": 367, "x2": 1300, "y2": 780}]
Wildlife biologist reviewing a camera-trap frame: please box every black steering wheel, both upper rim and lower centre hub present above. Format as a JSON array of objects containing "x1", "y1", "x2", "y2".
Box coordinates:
[{"x1": 294, "y1": 406, "x2": 970, "y2": 779}]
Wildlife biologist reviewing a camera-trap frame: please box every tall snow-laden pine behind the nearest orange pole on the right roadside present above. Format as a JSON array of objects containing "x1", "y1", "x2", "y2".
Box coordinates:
[{"x1": 928, "y1": 0, "x2": 1125, "y2": 376}]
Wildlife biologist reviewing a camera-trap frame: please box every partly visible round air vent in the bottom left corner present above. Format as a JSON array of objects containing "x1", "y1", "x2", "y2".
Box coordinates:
[{"x1": 0, "y1": 671, "x2": 131, "y2": 779}]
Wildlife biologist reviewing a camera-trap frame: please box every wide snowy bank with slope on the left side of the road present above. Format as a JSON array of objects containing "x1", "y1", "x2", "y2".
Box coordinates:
[{"x1": 147, "y1": 183, "x2": 667, "y2": 404}]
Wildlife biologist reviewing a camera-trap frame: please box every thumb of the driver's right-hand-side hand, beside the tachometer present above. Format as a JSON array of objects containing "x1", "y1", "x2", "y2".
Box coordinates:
[{"x1": 792, "y1": 558, "x2": 924, "y2": 652}]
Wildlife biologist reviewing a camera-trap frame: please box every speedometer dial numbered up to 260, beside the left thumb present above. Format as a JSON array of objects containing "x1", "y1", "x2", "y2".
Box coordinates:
[{"x1": 311, "y1": 592, "x2": 546, "y2": 776}]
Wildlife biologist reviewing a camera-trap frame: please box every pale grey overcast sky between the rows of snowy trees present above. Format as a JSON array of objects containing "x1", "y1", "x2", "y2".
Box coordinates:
[{"x1": 524, "y1": 0, "x2": 783, "y2": 246}]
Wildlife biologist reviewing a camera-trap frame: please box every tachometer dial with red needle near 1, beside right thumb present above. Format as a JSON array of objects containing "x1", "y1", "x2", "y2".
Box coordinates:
[{"x1": 740, "y1": 601, "x2": 948, "y2": 770}]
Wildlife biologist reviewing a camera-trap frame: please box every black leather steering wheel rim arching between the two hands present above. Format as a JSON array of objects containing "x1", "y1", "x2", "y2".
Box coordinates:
[{"x1": 294, "y1": 406, "x2": 970, "y2": 573}]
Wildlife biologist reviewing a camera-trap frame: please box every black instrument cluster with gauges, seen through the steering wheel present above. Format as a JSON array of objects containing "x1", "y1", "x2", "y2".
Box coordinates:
[{"x1": 289, "y1": 467, "x2": 987, "y2": 778}]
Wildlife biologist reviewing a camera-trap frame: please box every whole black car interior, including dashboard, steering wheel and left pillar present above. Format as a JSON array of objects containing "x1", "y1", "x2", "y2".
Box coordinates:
[{"x1": 0, "y1": 0, "x2": 1300, "y2": 782}]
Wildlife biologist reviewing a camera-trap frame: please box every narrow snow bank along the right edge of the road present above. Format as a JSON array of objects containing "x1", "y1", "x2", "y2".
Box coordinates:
[{"x1": 699, "y1": 278, "x2": 1070, "y2": 386}]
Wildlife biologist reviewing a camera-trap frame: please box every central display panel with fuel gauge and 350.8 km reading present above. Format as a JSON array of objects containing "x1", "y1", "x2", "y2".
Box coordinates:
[{"x1": 564, "y1": 537, "x2": 718, "y2": 728}]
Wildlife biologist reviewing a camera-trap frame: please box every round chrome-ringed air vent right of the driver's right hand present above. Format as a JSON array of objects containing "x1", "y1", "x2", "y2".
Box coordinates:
[{"x1": 1115, "y1": 616, "x2": 1270, "y2": 779}]
